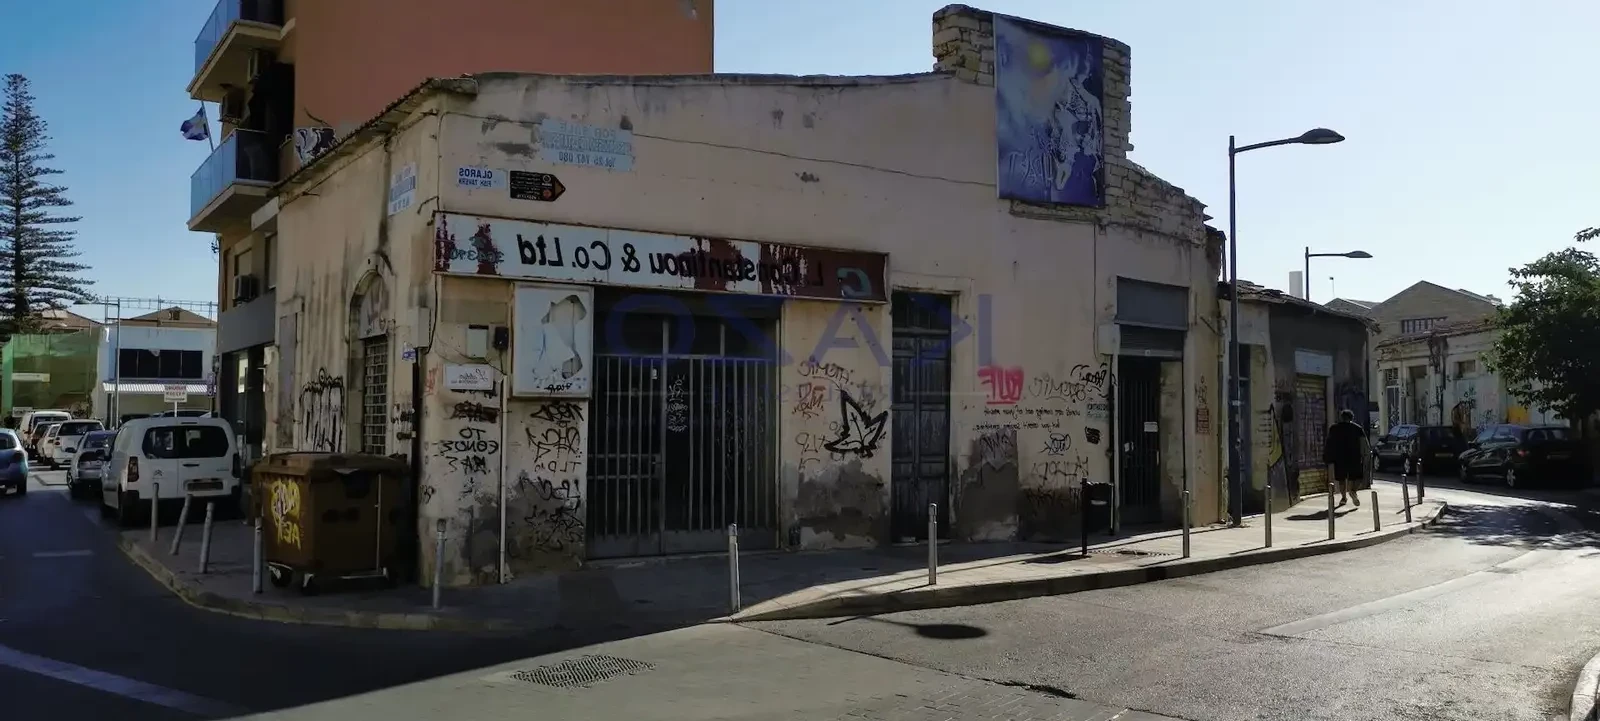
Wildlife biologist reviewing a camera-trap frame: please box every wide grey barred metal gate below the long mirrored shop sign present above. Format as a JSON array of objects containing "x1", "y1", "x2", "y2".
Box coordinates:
[{"x1": 586, "y1": 313, "x2": 778, "y2": 558}]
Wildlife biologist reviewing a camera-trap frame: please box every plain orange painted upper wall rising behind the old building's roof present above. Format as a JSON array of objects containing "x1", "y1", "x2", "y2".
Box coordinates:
[{"x1": 285, "y1": 0, "x2": 714, "y2": 134}]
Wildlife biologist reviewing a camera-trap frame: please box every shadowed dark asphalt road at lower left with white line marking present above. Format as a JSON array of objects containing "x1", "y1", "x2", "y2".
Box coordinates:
[{"x1": 0, "y1": 472, "x2": 649, "y2": 721}]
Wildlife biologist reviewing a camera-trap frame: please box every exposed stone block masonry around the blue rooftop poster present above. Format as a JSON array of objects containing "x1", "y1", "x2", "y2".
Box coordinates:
[{"x1": 933, "y1": 5, "x2": 1206, "y2": 245}]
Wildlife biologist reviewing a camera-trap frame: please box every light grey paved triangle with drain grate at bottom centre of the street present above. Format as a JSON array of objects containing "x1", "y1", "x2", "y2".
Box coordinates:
[{"x1": 251, "y1": 623, "x2": 1170, "y2": 721}]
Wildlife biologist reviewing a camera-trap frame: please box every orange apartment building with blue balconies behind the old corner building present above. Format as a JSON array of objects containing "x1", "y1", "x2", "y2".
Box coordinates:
[{"x1": 187, "y1": 0, "x2": 714, "y2": 463}]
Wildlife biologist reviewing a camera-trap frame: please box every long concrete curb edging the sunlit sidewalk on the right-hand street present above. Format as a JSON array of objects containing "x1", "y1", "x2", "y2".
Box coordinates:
[{"x1": 732, "y1": 500, "x2": 1448, "y2": 623}]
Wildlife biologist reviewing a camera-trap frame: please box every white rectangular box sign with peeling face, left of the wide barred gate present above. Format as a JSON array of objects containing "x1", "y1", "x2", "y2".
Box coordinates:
[{"x1": 510, "y1": 285, "x2": 595, "y2": 398}]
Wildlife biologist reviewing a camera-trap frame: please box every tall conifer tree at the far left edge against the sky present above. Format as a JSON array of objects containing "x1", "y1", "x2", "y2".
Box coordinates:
[{"x1": 0, "y1": 74, "x2": 94, "y2": 337}]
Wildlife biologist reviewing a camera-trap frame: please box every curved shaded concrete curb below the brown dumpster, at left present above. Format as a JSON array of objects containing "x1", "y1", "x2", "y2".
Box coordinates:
[{"x1": 117, "y1": 534, "x2": 534, "y2": 633}]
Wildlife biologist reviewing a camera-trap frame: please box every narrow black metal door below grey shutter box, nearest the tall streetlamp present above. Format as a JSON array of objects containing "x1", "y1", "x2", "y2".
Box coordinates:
[{"x1": 1117, "y1": 357, "x2": 1162, "y2": 524}]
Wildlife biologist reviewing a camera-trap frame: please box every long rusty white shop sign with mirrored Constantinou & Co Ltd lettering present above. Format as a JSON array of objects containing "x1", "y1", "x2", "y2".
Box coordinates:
[{"x1": 434, "y1": 213, "x2": 888, "y2": 302}]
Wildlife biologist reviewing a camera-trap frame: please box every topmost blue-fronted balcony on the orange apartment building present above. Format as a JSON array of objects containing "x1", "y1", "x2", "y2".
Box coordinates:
[{"x1": 189, "y1": 0, "x2": 283, "y2": 102}]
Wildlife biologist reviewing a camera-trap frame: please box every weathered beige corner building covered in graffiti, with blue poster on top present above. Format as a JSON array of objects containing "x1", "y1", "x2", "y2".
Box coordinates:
[{"x1": 267, "y1": 6, "x2": 1224, "y2": 584}]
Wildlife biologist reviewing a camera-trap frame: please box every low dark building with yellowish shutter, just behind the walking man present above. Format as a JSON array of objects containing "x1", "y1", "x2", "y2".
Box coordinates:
[{"x1": 1221, "y1": 281, "x2": 1376, "y2": 513}]
